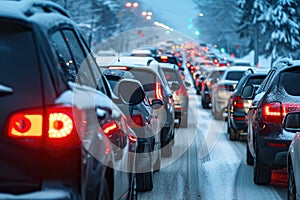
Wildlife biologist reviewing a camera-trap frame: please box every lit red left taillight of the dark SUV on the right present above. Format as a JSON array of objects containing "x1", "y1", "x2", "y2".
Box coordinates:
[{"x1": 262, "y1": 102, "x2": 282, "y2": 123}]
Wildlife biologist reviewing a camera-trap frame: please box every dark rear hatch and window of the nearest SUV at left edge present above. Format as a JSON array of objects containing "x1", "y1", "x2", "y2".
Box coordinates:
[{"x1": 0, "y1": 21, "x2": 43, "y2": 193}]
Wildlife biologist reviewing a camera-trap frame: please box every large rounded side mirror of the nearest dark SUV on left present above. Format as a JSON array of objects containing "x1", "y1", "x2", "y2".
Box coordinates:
[{"x1": 118, "y1": 79, "x2": 145, "y2": 105}]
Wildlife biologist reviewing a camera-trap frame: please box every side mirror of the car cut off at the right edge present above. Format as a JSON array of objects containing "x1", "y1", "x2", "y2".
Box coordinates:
[{"x1": 282, "y1": 112, "x2": 300, "y2": 132}]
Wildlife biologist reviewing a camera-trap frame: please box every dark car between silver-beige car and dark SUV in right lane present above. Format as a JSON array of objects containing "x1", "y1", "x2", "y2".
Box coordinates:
[{"x1": 227, "y1": 69, "x2": 268, "y2": 140}]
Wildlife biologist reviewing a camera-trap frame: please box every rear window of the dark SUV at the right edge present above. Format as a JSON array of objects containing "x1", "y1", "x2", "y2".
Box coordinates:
[{"x1": 280, "y1": 67, "x2": 300, "y2": 96}]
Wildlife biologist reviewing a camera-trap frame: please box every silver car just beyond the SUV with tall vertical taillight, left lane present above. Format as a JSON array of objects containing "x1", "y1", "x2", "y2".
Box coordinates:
[{"x1": 161, "y1": 65, "x2": 191, "y2": 128}]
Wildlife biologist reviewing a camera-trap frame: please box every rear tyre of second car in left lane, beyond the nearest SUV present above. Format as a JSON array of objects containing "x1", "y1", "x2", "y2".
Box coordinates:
[{"x1": 136, "y1": 171, "x2": 153, "y2": 192}]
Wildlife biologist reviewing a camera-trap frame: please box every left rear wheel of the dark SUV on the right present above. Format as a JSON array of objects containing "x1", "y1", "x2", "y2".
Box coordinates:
[{"x1": 253, "y1": 153, "x2": 272, "y2": 185}]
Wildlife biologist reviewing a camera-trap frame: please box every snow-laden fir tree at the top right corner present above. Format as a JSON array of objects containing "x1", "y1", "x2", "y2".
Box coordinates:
[{"x1": 265, "y1": 0, "x2": 300, "y2": 61}]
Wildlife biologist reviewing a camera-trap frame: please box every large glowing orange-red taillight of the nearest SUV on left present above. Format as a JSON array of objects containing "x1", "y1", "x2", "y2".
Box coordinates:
[{"x1": 8, "y1": 106, "x2": 86, "y2": 147}]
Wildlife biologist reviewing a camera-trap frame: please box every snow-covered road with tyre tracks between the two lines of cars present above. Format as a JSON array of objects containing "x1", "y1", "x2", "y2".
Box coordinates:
[{"x1": 139, "y1": 85, "x2": 287, "y2": 200}]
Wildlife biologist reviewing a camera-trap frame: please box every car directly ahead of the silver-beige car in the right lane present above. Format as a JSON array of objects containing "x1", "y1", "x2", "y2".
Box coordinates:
[{"x1": 200, "y1": 67, "x2": 226, "y2": 108}]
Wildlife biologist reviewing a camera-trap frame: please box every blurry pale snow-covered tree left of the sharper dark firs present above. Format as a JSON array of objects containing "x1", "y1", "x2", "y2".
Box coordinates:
[{"x1": 193, "y1": 0, "x2": 244, "y2": 57}]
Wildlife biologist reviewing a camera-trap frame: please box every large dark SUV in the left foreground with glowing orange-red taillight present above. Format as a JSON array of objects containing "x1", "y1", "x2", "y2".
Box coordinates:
[{"x1": 0, "y1": 1, "x2": 136, "y2": 199}]
